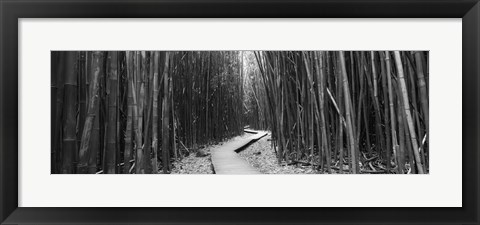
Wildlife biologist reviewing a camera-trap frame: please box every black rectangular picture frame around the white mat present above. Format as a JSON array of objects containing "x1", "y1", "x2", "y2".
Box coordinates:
[{"x1": 0, "y1": 0, "x2": 480, "y2": 224}]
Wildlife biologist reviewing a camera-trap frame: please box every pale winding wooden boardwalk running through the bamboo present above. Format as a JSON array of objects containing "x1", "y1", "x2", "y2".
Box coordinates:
[{"x1": 211, "y1": 129, "x2": 267, "y2": 174}]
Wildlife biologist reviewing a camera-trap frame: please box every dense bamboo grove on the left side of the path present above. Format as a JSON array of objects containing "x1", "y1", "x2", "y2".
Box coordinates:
[{"x1": 51, "y1": 51, "x2": 244, "y2": 174}]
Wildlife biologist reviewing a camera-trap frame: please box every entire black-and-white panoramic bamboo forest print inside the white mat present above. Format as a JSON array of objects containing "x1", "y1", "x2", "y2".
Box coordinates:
[{"x1": 51, "y1": 51, "x2": 430, "y2": 174}]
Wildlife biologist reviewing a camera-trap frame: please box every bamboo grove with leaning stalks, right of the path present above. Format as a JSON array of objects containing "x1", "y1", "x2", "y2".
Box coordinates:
[{"x1": 251, "y1": 51, "x2": 429, "y2": 174}]
